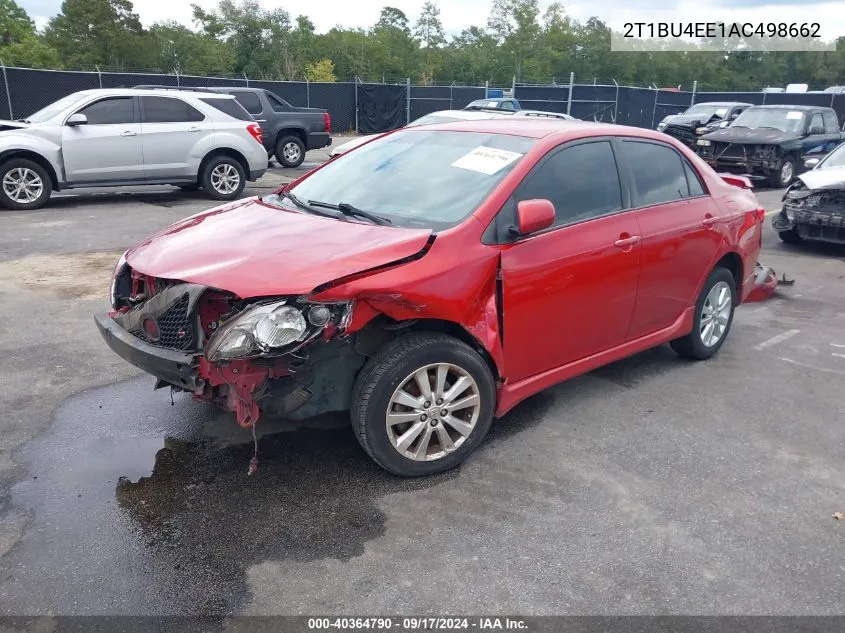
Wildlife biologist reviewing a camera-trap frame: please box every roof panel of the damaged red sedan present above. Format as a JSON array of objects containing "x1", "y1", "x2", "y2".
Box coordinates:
[{"x1": 414, "y1": 117, "x2": 652, "y2": 142}]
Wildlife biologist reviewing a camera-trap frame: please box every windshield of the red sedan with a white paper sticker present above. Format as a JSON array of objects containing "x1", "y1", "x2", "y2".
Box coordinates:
[{"x1": 276, "y1": 129, "x2": 536, "y2": 230}]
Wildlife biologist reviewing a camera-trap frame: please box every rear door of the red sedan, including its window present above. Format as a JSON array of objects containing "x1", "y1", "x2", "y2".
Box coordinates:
[{"x1": 617, "y1": 139, "x2": 730, "y2": 340}]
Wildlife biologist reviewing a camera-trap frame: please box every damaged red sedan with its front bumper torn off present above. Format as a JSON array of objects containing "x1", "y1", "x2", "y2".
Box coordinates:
[{"x1": 95, "y1": 119, "x2": 763, "y2": 476}]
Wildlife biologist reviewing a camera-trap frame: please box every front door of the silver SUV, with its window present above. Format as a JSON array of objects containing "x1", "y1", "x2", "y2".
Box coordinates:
[{"x1": 62, "y1": 96, "x2": 144, "y2": 184}]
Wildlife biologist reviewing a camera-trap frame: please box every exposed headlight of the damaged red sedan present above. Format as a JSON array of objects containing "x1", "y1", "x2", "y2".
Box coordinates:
[{"x1": 205, "y1": 300, "x2": 348, "y2": 362}]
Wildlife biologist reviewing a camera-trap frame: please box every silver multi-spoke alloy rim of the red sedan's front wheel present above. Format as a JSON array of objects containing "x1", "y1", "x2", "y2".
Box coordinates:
[{"x1": 385, "y1": 363, "x2": 481, "y2": 461}]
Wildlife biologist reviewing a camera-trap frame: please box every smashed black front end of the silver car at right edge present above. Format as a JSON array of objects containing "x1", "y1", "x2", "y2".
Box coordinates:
[{"x1": 772, "y1": 180, "x2": 845, "y2": 244}]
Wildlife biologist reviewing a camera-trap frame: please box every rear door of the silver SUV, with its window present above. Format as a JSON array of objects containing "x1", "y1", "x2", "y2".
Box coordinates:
[{"x1": 139, "y1": 95, "x2": 214, "y2": 180}]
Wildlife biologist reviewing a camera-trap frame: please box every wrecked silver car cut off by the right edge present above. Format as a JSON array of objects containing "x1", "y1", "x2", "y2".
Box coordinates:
[{"x1": 772, "y1": 143, "x2": 845, "y2": 244}]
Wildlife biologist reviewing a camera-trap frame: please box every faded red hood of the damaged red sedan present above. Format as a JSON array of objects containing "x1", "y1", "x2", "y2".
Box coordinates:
[{"x1": 126, "y1": 198, "x2": 431, "y2": 299}]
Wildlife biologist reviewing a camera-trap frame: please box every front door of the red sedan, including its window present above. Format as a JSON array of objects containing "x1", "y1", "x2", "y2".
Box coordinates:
[{"x1": 497, "y1": 140, "x2": 640, "y2": 381}]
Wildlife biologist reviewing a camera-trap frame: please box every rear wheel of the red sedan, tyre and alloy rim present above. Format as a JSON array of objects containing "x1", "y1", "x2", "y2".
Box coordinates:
[{"x1": 670, "y1": 268, "x2": 736, "y2": 360}]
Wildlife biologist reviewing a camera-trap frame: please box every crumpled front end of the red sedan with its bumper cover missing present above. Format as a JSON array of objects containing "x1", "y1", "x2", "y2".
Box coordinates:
[{"x1": 95, "y1": 262, "x2": 366, "y2": 428}]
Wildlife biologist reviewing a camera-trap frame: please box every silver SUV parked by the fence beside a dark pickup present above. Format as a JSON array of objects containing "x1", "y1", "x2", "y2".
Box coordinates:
[{"x1": 0, "y1": 88, "x2": 267, "y2": 209}]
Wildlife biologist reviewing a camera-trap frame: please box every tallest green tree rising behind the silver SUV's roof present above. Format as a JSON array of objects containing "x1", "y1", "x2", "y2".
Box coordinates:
[{"x1": 44, "y1": 0, "x2": 152, "y2": 68}]
